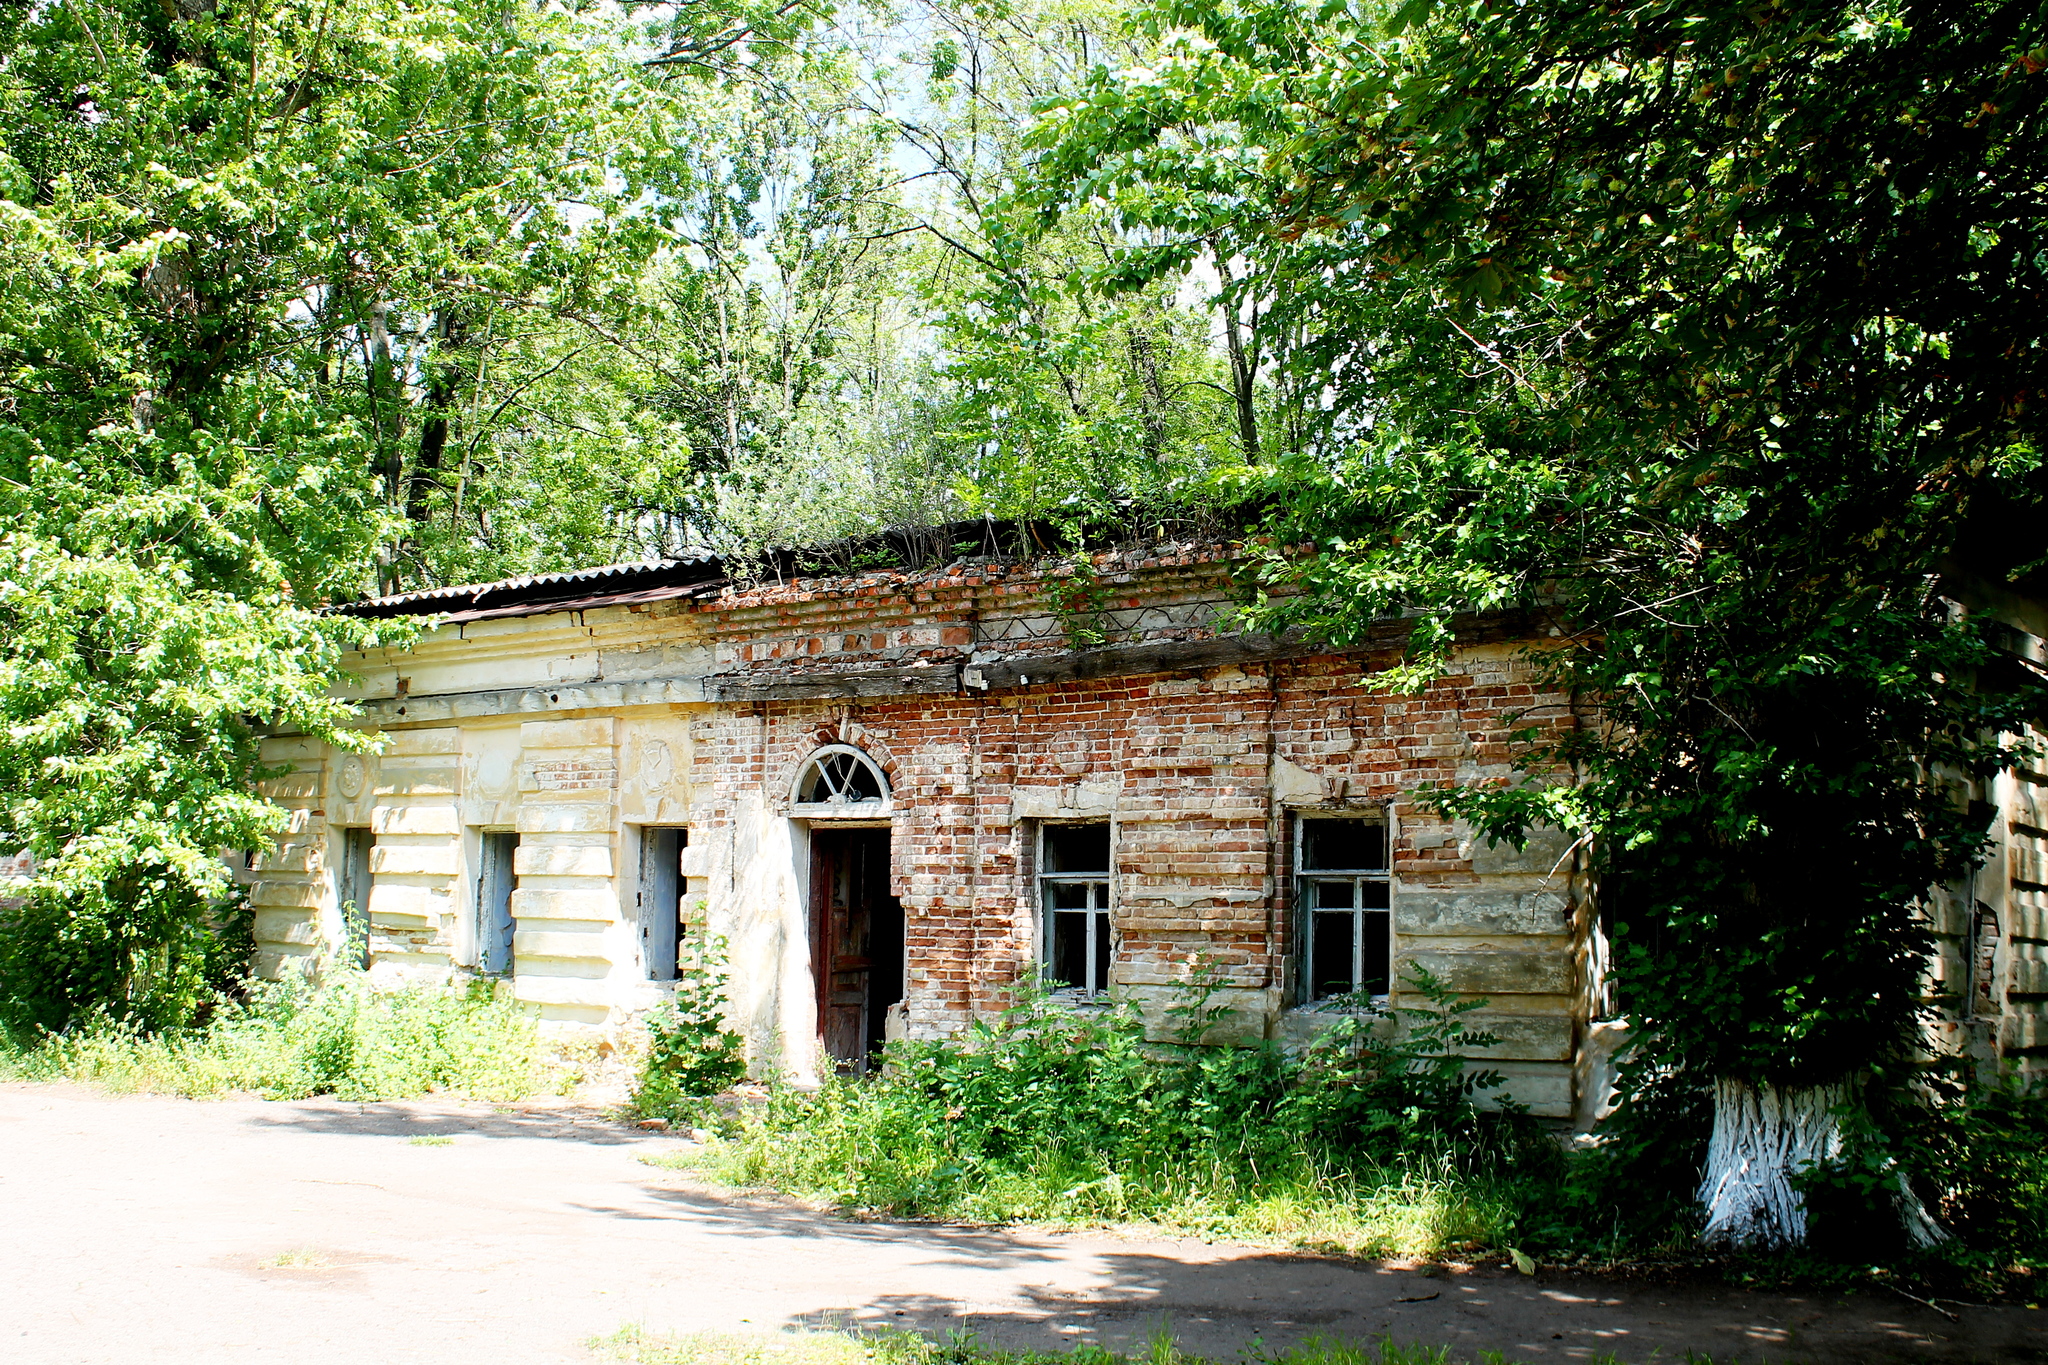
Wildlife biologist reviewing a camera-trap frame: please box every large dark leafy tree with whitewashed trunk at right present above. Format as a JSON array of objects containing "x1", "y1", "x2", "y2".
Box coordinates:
[{"x1": 1034, "y1": 0, "x2": 2048, "y2": 1244}]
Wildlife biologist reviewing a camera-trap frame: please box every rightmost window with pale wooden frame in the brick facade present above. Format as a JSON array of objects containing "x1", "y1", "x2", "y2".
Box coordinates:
[{"x1": 1294, "y1": 819, "x2": 1393, "y2": 1001}]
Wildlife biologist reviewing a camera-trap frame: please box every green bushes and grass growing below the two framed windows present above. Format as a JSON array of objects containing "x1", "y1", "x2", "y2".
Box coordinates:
[{"x1": 692, "y1": 976, "x2": 1559, "y2": 1254}]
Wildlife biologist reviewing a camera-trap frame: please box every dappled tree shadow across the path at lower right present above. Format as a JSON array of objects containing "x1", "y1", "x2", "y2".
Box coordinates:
[{"x1": 618, "y1": 1187, "x2": 2048, "y2": 1365}]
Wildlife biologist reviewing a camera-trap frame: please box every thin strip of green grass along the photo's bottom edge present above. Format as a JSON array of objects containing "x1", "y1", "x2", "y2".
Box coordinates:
[{"x1": 590, "y1": 1326, "x2": 1662, "y2": 1365}]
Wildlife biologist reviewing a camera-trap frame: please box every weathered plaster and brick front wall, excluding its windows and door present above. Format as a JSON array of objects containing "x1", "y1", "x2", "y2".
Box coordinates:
[{"x1": 254, "y1": 555, "x2": 1589, "y2": 1115}]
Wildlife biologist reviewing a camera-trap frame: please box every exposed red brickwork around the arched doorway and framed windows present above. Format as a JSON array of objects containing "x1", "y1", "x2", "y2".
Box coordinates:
[{"x1": 694, "y1": 553, "x2": 1571, "y2": 1031}]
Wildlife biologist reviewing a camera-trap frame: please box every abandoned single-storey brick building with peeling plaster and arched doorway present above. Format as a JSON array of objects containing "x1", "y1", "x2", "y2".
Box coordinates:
[{"x1": 252, "y1": 544, "x2": 2048, "y2": 1119}]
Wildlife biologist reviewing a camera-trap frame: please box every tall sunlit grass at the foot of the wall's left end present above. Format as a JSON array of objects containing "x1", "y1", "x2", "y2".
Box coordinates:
[{"x1": 0, "y1": 968, "x2": 557, "y2": 1101}]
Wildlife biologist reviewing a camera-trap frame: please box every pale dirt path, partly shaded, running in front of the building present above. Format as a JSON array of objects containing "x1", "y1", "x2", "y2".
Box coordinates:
[{"x1": 0, "y1": 1085, "x2": 2048, "y2": 1365}]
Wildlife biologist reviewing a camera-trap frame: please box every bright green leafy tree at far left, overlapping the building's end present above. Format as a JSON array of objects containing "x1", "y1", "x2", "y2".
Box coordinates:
[{"x1": 0, "y1": 0, "x2": 696, "y2": 1025}]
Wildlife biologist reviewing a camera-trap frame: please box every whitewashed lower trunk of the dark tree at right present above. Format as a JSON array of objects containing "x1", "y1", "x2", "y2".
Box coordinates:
[{"x1": 1700, "y1": 1076, "x2": 1847, "y2": 1248}]
